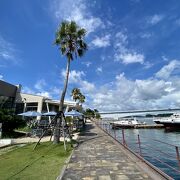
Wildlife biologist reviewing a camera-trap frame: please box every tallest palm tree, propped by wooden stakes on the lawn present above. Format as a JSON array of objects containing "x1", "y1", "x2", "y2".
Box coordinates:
[{"x1": 54, "y1": 21, "x2": 87, "y2": 143}]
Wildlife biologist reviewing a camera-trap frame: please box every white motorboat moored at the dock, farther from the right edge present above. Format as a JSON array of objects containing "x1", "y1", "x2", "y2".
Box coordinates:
[{"x1": 110, "y1": 118, "x2": 145, "y2": 129}]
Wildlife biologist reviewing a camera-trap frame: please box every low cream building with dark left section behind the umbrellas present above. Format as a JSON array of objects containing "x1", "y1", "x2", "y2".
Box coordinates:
[{"x1": 0, "y1": 80, "x2": 82, "y2": 114}]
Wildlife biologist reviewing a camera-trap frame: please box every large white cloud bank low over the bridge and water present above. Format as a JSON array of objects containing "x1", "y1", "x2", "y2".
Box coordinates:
[{"x1": 81, "y1": 66, "x2": 180, "y2": 111}]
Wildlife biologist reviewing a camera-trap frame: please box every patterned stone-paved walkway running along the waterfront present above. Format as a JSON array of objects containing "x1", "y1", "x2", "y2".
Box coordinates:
[{"x1": 58, "y1": 122, "x2": 167, "y2": 180}]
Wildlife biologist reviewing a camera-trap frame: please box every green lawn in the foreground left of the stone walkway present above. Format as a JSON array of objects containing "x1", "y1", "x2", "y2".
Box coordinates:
[{"x1": 0, "y1": 142, "x2": 72, "y2": 180}]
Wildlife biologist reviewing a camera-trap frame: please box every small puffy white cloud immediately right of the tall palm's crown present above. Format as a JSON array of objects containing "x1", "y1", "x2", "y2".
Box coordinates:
[{"x1": 91, "y1": 35, "x2": 110, "y2": 48}]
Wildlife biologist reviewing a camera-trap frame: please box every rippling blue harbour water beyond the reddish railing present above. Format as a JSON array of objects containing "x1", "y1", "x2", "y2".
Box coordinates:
[{"x1": 102, "y1": 118, "x2": 180, "y2": 179}]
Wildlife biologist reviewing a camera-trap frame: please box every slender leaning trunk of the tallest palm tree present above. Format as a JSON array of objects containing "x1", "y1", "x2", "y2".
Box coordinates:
[{"x1": 53, "y1": 59, "x2": 70, "y2": 144}]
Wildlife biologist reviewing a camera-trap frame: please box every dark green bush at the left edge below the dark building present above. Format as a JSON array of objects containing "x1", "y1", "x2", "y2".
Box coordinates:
[{"x1": 0, "y1": 109, "x2": 26, "y2": 133}]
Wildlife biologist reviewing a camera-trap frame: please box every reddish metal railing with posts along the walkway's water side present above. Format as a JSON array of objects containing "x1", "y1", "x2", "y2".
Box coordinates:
[{"x1": 96, "y1": 121, "x2": 180, "y2": 178}]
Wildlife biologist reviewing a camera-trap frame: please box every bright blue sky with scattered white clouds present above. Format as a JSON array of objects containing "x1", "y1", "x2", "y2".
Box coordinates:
[{"x1": 0, "y1": 0, "x2": 180, "y2": 111}]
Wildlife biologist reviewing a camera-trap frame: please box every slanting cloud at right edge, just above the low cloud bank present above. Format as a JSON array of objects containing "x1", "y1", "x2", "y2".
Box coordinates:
[{"x1": 156, "y1": 60, "x2": 180, "y2": 79}]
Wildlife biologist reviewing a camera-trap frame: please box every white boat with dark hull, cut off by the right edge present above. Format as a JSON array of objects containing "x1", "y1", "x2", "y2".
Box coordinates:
[{"x1": 153, "y1": 113, "x2": 180, "y2": 129}]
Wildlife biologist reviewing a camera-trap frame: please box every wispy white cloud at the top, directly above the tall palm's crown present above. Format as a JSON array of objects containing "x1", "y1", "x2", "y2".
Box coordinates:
[{"x1": 51, "y1": 0, "x2": 104, "y2": 33}]
